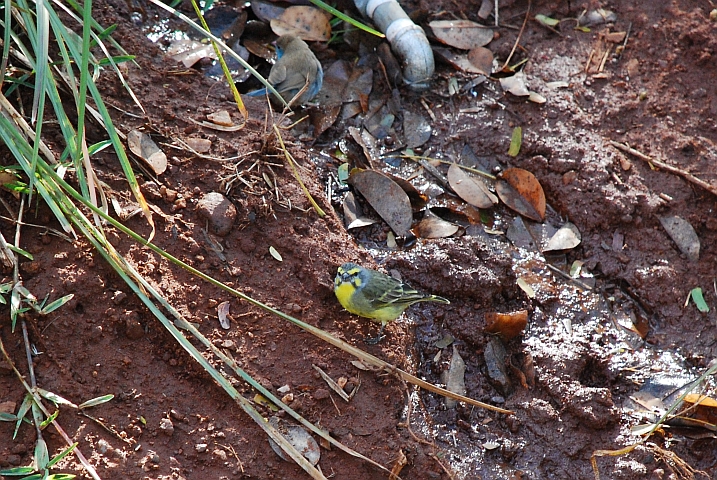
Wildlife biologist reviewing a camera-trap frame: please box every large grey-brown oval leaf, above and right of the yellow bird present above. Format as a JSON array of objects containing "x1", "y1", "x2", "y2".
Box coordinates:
[{"x1": 348, "y1": 170, "x2": 413, "y2": 237}]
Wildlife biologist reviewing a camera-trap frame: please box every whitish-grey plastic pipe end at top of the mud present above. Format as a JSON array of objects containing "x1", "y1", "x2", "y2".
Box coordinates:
[{"x1": 354, "y1": 0, "x2": 435, "y2": 90}]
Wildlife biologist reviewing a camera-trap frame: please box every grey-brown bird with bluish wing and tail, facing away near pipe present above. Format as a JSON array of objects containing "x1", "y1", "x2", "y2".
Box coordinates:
[{"x1": 247, "y1": 35, "x2": 324, "y2": 105}]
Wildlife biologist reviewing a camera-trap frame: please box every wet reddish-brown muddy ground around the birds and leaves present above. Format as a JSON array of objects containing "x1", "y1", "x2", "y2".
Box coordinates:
[{"x1": 0, "y1": 0, "x2": 717, "y2": 479}]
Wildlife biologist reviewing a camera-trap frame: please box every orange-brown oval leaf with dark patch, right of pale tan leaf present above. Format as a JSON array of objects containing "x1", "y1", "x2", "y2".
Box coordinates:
[{"x1": 495, "y1": 168, "x2": 545, "y2": 222}]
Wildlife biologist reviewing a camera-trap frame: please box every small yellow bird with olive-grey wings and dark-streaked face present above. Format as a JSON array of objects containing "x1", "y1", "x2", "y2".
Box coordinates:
[{"x1": 334, "y1": 263, "x2": 451, "y2": 344}]
